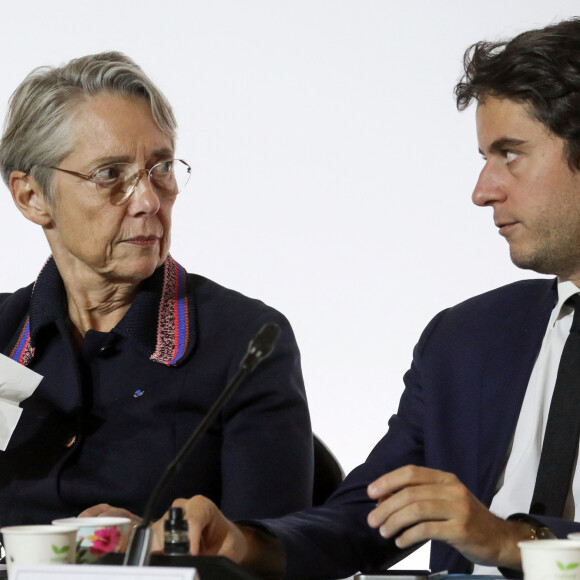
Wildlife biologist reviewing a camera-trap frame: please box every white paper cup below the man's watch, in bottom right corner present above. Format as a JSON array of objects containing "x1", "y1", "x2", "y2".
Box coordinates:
[{"x1": 518, "y1": 540, "x2": 580, "y2": 580}]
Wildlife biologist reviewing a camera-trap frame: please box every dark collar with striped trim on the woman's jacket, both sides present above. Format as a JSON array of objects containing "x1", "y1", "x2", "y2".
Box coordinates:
[{"x1": 10, "y1": 256, "x2": 196, "y2": 366}]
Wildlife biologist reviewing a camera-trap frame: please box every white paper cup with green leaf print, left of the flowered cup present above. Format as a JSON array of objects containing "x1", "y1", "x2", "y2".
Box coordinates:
[{"x1": 0, "y1": 525, "x2": 77, "y2": 575}]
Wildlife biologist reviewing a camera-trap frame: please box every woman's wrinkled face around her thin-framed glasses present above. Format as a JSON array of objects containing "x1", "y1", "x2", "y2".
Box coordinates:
[{"x1": 45, "y1": 93, "x2": 175, "y2": 284}]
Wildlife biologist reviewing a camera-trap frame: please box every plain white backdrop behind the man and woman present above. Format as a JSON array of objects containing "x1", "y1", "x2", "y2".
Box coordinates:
[{"x1": 0, "y1": 0, "x2": 578, "y2": 572}]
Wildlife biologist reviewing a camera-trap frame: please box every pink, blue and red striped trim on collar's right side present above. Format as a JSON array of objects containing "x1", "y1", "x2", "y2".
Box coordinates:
[{"x1": 150, "y1": 256, "x2": 189, "y2": 366}]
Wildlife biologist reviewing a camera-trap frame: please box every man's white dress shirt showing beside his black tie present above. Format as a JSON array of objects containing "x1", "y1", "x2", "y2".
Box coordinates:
[{"x1": 473, "y1": 282, "x2": 580, "y2": 574}]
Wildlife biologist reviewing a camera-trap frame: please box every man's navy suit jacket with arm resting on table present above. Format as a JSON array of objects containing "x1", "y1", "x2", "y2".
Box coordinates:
[{"x1": 265, "y1": 280, "x2": 580, "y2": 580}]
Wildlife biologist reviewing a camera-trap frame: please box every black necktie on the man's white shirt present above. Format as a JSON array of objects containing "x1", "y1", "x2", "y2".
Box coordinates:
[{"x1": 530, "y1": 294, "x2": 580, "y2": 517}]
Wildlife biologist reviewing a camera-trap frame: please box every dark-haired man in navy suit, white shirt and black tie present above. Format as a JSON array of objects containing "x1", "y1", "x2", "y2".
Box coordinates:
[{"x1": 157, "y1": 19, "x2": 580, "y2": 580}]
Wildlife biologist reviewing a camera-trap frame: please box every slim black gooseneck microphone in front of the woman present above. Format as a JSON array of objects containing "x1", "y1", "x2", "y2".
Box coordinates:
[{"x1": 123, "y1": 322, "x2": 280, "y2": 566}]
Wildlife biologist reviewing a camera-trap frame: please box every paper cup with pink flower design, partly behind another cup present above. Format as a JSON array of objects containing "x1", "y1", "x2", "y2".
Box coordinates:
[{"x1": 52, "y1": 517, "x2": 131, "y2": 564}]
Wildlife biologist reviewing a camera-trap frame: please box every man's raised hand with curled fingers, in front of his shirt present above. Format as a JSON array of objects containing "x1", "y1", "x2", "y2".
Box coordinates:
[{"x1": 368, "y1": 465, "x2": 530, "y2": 570}]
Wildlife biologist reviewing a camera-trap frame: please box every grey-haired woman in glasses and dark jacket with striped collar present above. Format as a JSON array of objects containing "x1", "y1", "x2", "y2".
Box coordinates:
[{"x1": 0, "y1": 52, "x2": 312, "y2": 526}]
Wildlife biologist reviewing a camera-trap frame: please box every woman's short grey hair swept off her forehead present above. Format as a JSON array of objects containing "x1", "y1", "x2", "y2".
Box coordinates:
[{"x1": 0, "y1": 52, "x2": 177, "y2": 204}]
